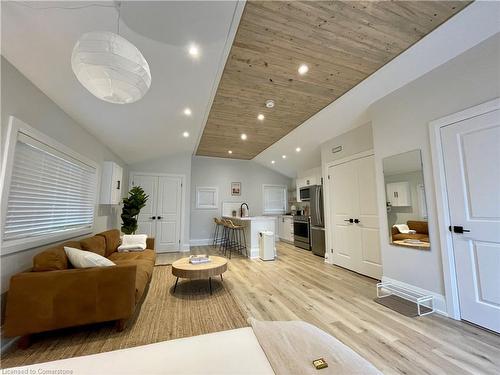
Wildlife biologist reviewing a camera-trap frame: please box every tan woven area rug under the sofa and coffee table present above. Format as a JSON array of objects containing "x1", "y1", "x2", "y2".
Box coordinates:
[{"x1": 1, "y1": 266, "x2": 248, "y2": 368}]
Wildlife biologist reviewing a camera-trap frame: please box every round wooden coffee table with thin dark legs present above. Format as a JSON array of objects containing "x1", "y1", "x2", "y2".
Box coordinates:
[{"x1": 172, "y1": 256, "x2": 227, "y2": 294}]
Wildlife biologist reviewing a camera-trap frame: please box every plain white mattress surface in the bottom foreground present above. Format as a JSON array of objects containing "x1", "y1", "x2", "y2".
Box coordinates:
[{"x1": 11, "y1": 327, "x2": 274, "y2": 375}]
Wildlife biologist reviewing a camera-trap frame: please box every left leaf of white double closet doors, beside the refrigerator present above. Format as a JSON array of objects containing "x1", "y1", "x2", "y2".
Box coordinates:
[{"x1": 328, "y1": 163, "x2": 361, "y2": 272}]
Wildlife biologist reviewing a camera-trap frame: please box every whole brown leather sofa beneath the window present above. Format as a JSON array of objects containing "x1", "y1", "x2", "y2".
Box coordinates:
[{"x1": 4, "y1": 230, "x2": 156, "y2": 337}]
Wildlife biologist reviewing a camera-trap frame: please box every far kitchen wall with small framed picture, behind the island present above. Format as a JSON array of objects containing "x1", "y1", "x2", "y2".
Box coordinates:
[{"x1": 191, "y1": 156, "x2": 292, "y2": 245}]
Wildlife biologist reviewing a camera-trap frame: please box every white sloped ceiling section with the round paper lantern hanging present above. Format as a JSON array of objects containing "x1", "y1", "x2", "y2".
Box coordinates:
[{"x1": 1, "y1": 1, "x2": 241, "y2": 164}]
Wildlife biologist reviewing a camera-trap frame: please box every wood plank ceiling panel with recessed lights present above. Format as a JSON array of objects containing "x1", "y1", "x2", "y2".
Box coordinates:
[{"x1": 197, "y1": 1, "x2": 470, "y2": 159}]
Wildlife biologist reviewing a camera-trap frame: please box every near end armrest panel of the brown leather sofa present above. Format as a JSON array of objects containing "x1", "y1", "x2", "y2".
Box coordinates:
[{"x1": 5, "y1": 264, "x2": 136, "y2": 337}]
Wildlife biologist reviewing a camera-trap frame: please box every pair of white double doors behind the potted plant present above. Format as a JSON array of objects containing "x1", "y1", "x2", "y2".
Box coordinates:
[{"x1": 130, "y1": 173, "x2": 182, "y2": 252}]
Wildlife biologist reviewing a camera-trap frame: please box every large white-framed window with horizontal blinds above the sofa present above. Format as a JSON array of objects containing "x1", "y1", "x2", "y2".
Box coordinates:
[{"x1": 2, "y1": 117, "x2": 97, "y2": 254}]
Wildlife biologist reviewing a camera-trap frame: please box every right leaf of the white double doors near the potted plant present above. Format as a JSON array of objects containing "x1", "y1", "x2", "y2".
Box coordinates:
[{"x1": 156, "y1": 176, "x2": 182, "y2": 251}]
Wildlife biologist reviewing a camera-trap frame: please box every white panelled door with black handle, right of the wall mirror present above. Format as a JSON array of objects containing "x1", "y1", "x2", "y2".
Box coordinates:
[{"x1": 441, "y1": 110, "x2": 500, "y2": 332}]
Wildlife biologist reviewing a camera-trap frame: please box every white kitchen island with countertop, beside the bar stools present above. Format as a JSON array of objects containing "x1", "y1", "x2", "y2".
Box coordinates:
[{"x1": 223, "y1": 216, "x2": 277, "y2": 258}]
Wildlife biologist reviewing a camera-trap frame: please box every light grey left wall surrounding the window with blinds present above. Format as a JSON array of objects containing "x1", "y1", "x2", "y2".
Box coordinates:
[{"x1": 1, "y1": 57, "x2": 126, "y2": 293}]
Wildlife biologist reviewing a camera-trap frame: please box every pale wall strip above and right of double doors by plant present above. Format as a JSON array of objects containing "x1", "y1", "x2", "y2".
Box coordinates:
[{"x1": 129, "y1": 152, "x2": 191, "y2": 250}]
